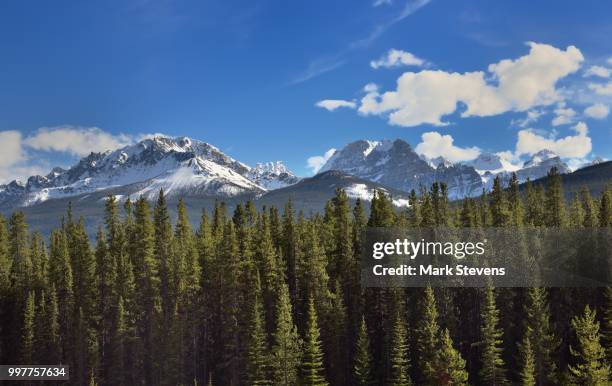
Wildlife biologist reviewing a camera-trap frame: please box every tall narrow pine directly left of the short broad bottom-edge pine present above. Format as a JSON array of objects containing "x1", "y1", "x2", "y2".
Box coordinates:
[{"x1": 416, "y1": 286, "x2": 440, "y2": 385}]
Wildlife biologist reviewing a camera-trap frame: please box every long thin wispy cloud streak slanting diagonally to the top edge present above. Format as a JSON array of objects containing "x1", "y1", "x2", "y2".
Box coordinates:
[{"x1": 289, "y1": 0, "x2": 431, "y2": 85}]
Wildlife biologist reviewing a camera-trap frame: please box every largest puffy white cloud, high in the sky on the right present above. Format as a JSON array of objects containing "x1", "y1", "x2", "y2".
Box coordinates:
[{"x1": 358, "y1": 42, "x2": 584, "y2": 127}]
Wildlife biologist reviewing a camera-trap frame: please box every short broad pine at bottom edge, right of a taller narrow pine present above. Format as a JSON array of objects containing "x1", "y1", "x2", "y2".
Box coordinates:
[{"x1": 435, "y1": 328, "x2": 468, "y2": 386}]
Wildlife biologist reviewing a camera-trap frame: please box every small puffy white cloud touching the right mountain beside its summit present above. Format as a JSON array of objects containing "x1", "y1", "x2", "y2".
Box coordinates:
[{"x1": 414, "y1": 131, "x2": 480, "y2": 162}]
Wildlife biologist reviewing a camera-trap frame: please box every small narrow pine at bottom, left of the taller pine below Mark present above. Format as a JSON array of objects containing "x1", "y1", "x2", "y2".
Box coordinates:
[{"x1": 387, "y1": 311, "x2": 412, "y2": 386}]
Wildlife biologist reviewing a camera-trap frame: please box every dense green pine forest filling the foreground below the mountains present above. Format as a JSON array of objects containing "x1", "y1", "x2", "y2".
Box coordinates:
[{"x1": 0, "y1": 169, "x2": 612, "y2": 386}]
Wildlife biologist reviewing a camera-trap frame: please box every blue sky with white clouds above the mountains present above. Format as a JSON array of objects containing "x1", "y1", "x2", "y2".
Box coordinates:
[{"x1": 0, "y1": 0, "x2": 612, "y2": 181}]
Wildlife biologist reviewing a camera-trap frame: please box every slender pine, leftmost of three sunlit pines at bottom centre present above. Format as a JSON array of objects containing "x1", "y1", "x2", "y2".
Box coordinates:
[{"x1": 246, "y1": 275, "x2": 272, "y2": 386}]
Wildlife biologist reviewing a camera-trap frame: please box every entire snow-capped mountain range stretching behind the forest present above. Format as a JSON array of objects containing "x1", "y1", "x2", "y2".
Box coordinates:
[{"x1": 0, "y1": 136, "x2": 609, "y2": 234}]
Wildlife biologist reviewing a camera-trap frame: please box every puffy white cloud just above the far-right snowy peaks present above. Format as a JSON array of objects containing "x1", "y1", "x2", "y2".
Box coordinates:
[{"x1": 516, "y1": 122, "x2": 592, "y2": 158}]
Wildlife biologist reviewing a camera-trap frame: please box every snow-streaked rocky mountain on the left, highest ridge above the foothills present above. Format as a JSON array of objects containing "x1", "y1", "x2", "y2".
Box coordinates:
[{"x1": 0, "y1": 136, "x2": 296, "y2": 206}]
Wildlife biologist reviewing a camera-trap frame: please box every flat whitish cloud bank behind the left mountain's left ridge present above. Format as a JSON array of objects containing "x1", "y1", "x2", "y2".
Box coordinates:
[{"x1": 24, "y1": 126, "x2": 133, "y2": 156}]
